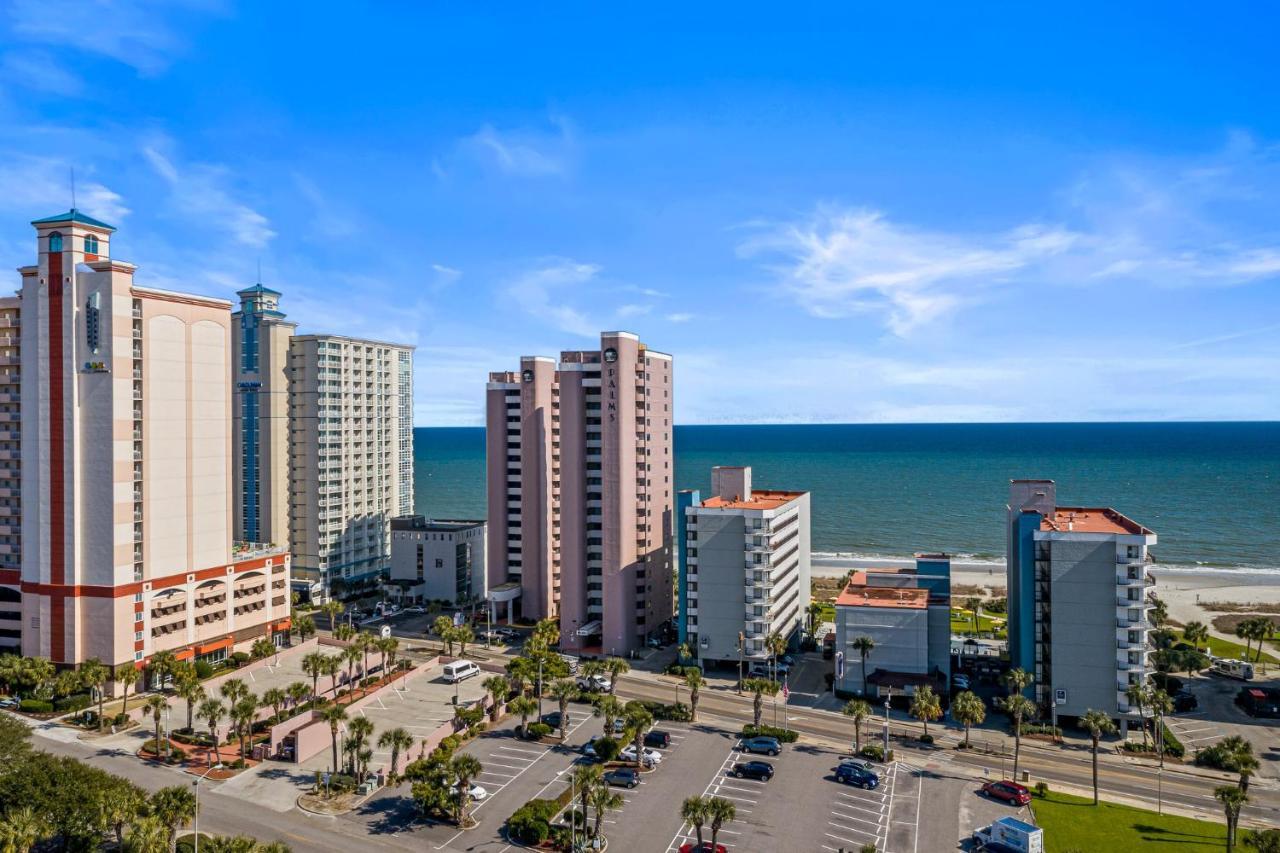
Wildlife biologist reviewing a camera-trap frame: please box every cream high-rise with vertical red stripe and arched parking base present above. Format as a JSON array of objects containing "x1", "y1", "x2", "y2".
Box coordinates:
[{"x1": 19, "y1": 210, "x2": 289, "y2": 667}]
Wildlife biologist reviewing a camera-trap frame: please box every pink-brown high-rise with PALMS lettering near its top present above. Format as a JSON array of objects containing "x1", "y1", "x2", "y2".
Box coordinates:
[{"x1": 485, "y1": 332, "x2": 675, "y2": 654}]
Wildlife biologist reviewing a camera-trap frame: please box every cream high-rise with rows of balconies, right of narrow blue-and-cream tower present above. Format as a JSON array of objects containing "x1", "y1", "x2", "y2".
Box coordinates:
[{"x1": 288, "y1": 334, "x2": 413, "y2": 597}]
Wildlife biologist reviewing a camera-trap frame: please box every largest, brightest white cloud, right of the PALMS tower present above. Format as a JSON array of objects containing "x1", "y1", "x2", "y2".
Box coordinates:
[{"x1": 741, "y1": 209, "x2": 1079, "y2": 334}]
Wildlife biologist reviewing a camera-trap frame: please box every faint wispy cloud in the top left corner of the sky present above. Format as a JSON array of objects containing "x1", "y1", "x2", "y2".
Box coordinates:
[{"x1": 6, "y1": 0, "x2": 220, "y2": 74}]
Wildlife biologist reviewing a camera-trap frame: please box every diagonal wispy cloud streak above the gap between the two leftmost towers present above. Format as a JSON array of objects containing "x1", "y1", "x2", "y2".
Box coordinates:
[{"x1": 142, "y1": 137, "x2": 275, "y2": 248}]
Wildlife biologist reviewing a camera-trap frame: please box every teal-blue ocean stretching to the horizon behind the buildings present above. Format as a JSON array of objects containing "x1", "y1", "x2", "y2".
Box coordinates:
[{"x1": 413, "y1": 423, "x2": 1280, "y2": 570}]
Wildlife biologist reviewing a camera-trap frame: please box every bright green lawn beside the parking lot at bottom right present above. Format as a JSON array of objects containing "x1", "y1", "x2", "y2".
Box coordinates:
[{"x1": 1032, "y1": 792, "x2": 1226, "y2": 853}]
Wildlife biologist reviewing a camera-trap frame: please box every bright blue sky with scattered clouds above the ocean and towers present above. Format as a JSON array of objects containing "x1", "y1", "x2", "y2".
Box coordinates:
[{"x1": 0, "y1": 0, "x2": 1280, "y2": 425}]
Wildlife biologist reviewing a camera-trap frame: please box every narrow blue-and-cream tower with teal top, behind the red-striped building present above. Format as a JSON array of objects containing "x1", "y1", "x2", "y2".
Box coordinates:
[{"x1": 232, "y1": 284, "x2": 297, "y2": 544}]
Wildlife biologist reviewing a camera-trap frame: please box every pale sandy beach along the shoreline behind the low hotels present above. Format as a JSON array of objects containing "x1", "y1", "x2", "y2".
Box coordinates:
[{"x1": 813, "y1": 553, "x2": 1280, "y2": 637}]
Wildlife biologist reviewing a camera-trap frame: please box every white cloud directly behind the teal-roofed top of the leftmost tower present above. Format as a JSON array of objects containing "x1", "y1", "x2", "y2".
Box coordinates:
[{"x1": 0, "y1": 154, "x2": 129, "y2": 225}]
